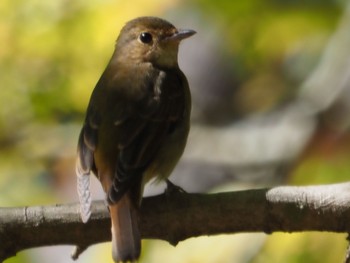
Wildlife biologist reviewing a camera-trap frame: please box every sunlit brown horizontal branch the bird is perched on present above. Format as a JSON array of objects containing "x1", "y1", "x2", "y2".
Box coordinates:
[{"x1": 0, "y1": 183, "x2": 350, "y2": 261}]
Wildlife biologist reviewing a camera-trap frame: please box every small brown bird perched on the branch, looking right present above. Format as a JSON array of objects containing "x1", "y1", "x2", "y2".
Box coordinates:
[{"x1": 76, "y1": 17, "x2": 195, "y2": 262}]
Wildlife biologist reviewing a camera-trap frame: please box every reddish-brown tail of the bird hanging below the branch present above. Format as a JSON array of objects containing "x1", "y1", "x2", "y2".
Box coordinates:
[{"x1": 109, "y1": 193, "x2": 141, "y2": 262}]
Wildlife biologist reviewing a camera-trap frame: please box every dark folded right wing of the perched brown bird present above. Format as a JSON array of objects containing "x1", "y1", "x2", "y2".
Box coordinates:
[{"x1": 108, "y1": 69, "x2": 185, "y2": 204}]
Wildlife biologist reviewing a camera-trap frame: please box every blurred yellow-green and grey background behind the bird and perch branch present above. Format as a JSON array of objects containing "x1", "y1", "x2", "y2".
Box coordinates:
[{"x1": 0, "y1": 0, "x2": 350, "y2": 263}]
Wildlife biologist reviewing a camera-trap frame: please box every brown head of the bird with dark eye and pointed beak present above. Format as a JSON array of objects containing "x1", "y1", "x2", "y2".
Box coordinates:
[{"x1": 115, "y1": 17, "x2": 196, "y2": 68}]
